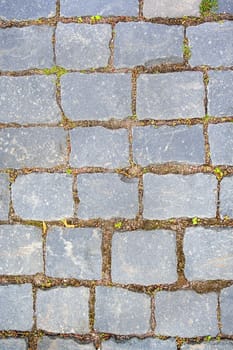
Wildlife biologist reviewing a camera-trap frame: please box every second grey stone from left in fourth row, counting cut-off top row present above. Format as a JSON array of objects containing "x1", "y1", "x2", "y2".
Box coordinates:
[{"x1": 70, "y1": 126, "x2": 129, "y2": 168}]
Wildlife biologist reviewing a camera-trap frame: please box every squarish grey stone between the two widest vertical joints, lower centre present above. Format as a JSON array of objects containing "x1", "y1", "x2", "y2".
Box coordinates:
[{"x1": 112, "y1": 230, "x2": 177, "y2": 285}]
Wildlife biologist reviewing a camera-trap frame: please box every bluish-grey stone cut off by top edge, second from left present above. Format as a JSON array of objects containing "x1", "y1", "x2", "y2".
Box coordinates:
[{"x1": 61, "y1": 0, "x2": 138, "y2": 17}]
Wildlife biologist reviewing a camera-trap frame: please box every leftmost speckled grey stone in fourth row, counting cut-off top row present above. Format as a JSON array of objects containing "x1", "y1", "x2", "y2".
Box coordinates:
[{"x1": 0, "y1": 128, "x2": 67, "y2": 169}]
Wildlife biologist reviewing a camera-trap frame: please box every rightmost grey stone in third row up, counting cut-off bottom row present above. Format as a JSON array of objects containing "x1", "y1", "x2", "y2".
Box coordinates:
[{"x1": 184, "y1": 227, "x2": 233, "y2": 280}]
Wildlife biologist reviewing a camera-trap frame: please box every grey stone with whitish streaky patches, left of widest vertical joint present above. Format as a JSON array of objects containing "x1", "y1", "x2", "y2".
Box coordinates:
[{"x1": 46, "y1": 227, "x2": 102, "y2": 280}]
